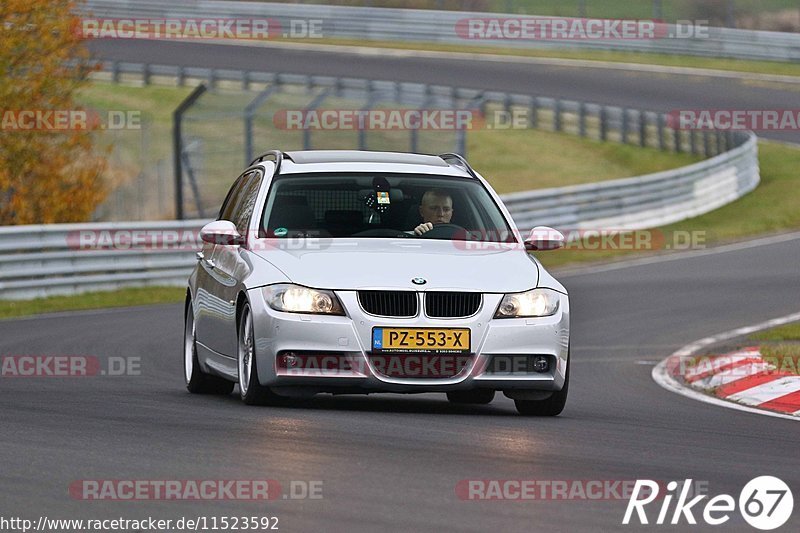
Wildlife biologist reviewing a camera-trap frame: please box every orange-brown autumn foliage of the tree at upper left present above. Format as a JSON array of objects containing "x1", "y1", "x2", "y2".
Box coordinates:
[{"x1": 0, "y1": 0, "x2": 106, "y2": 224}]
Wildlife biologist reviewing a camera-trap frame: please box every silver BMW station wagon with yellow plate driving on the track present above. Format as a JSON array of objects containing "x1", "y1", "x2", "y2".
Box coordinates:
[{"x1": 184, "y1": 150, "x2": 570, "y2": 416}]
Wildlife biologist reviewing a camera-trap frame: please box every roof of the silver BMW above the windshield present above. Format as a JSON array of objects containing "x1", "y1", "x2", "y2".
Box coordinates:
[{"x1": 262, "y1": 150, "x2": 474, "y2": 178}]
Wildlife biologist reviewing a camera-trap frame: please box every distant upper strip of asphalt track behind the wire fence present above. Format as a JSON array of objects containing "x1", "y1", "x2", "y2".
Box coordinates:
[{"x1": 90, "y1": 40, "x2": 800, "y2": 143}]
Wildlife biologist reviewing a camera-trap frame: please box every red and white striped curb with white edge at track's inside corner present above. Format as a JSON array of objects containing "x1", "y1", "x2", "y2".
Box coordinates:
[{"x1": 652, "y1": 313, "x2": 800, "y2": 420}]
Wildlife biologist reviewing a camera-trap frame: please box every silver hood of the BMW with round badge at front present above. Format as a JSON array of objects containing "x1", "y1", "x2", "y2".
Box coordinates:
[{"x1": 253, "y1": 239, "x2": 539, "y2": 292}]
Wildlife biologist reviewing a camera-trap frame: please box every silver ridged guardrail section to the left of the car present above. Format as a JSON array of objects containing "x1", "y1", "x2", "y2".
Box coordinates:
[{"x1": 0, "y1": 220, "x2": 203, "y2": 299}]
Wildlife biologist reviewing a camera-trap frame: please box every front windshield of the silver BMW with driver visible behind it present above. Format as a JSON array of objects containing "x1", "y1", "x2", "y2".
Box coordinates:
[{"x1": 260, "y1": 174, "x2": 514, "y2": 242}]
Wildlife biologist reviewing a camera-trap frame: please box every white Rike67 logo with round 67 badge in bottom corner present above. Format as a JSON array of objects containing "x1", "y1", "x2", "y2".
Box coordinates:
[{"x1": 622, "y1": 476, "x2": 794, "y2": 531}]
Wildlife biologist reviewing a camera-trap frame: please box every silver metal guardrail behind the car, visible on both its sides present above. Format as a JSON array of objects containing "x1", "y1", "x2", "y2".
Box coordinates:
[{"x1": 0, "y1": 130, "x2": 759, "y2": 299}]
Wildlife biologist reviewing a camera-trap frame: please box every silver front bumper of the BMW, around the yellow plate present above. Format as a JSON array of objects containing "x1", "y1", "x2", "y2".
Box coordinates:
[{"x1": 249, "y1": 289, "x2": 569, "y2": 393}]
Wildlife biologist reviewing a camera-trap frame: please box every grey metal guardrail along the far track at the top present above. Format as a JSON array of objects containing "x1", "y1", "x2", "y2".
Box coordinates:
[{"x1": 84, "y1": 0, "x2": 800, "y2": 61}]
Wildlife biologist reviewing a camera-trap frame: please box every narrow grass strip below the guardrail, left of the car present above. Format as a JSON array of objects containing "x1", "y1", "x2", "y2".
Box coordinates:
[{"x1": 0, "y1": 287, "x2": 186, "y2": 318}]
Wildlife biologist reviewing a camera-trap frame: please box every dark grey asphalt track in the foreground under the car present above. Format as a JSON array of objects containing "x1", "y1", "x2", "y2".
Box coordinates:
[{"x1": 0, "y1": 235, "x2": 800, "y2": 531}]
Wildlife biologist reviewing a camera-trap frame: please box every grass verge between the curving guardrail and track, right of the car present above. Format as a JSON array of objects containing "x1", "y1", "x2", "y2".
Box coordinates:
[{"x1": 536, "y1": 142, "x2": 800, "y2": 268}]
